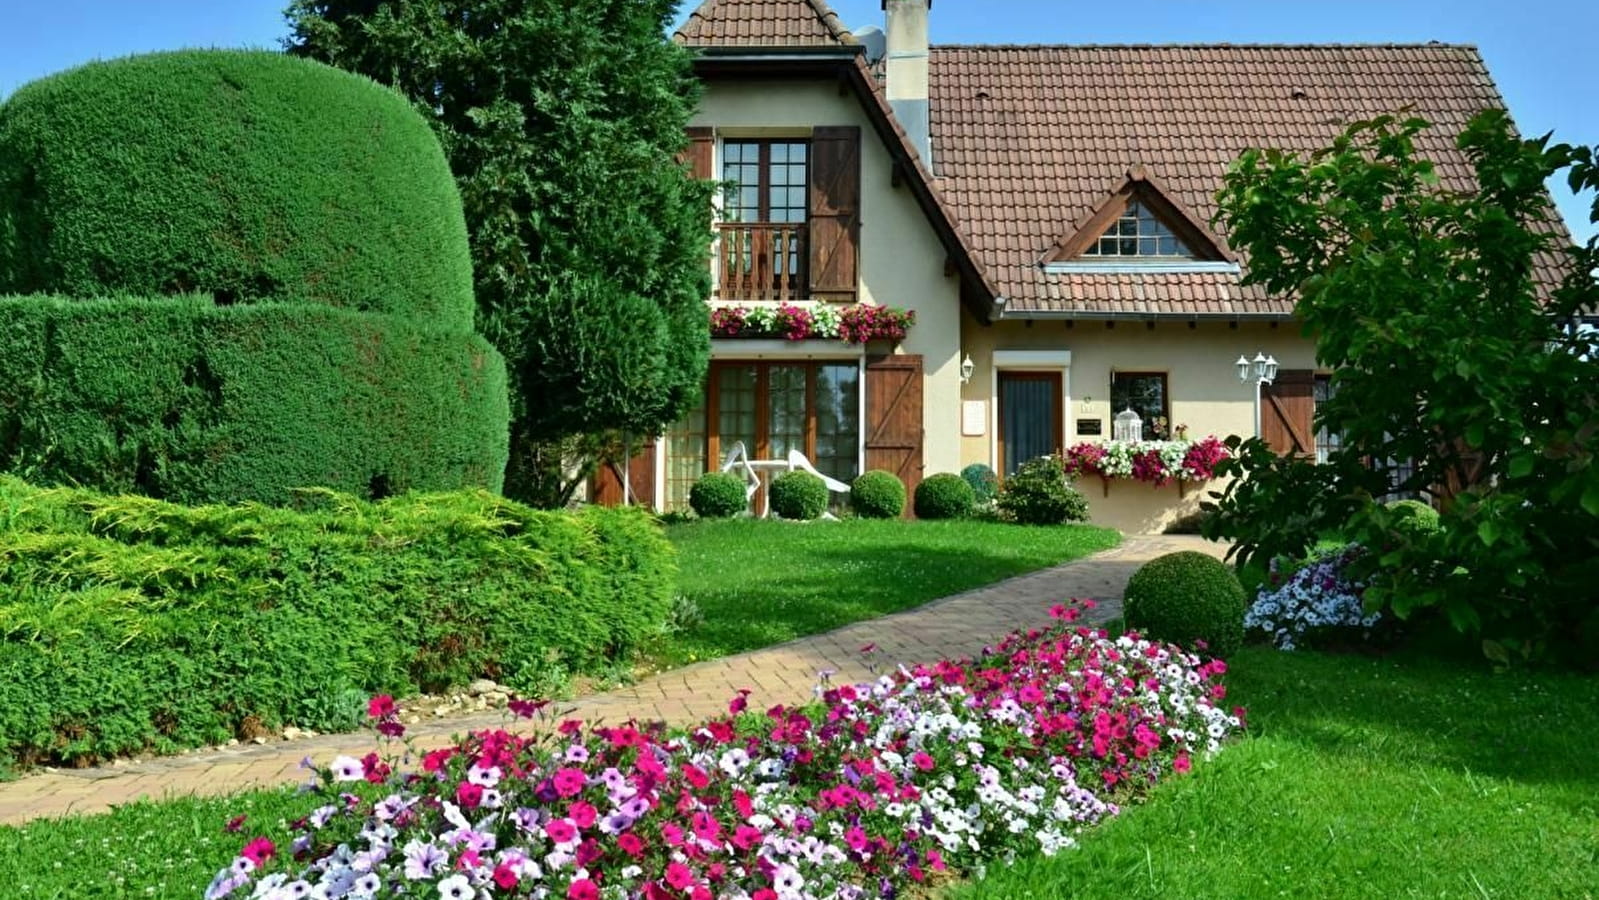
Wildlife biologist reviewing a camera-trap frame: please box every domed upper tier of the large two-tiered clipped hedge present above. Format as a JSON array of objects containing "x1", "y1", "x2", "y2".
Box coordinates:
[{"x1": 0, "y1": 50, "x2": 475, "y2": 333}]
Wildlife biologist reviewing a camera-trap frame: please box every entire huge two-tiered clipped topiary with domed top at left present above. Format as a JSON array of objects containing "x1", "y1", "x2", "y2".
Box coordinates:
[{"x1": 0, "y1": 51, "x2": 510, "y2": 504}]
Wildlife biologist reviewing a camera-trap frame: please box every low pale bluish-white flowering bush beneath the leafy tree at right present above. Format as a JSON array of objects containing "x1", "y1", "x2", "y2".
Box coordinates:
[{"x1": 1244, "y1": 545, "x2": 1382, "y2": 651}]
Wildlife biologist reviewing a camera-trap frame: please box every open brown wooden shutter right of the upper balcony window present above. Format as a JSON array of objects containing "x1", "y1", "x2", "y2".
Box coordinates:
[{"x1": 809, "y1": 125, "x2": 860, "y2": 301}]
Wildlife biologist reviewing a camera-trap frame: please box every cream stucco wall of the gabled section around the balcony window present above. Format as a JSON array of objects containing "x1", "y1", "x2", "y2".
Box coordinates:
[{"x1": 691, "y1": 82, "x2": 961, "y2": 475}]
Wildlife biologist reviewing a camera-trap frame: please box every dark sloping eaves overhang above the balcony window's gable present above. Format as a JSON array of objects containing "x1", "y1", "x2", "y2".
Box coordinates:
[{"x1": 694, "y1": 46, "x2": 1003, "y2": 323}]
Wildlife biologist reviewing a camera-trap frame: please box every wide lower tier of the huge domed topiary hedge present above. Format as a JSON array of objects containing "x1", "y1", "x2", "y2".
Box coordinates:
[{"x1": 0, "y1": 297, "x2": 508, "y2": 504}]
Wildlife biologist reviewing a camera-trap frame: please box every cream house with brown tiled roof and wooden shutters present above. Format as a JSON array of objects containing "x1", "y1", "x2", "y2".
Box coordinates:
[{"x1": 611, "y1": 0, "x2": 1547, "y2": 531}]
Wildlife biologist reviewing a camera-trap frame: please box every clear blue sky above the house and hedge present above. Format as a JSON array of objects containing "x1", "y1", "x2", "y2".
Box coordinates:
[{"x1": 0, "y1": 0, "x2": 1599, "y2": 237}]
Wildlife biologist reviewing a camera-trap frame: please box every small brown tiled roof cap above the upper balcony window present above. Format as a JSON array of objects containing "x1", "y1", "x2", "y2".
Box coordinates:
[{"x1": 673, "y1": 0, "x2": 859, "y2": 48}]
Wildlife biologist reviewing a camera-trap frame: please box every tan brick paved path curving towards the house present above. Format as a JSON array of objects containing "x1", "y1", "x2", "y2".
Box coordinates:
[{"x1": 0, "y1": 536, "x2": 1222, "y2": 825}]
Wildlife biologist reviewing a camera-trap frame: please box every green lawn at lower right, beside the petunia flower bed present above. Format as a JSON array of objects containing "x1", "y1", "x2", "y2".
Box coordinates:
[{"x1": 948, "y1": 647, "x2": 1599, "y2": 900}]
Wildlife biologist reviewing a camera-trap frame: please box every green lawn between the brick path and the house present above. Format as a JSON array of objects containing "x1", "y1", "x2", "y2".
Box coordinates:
[{"x1": 656, "y1": 520, "x2": 1119, "y2": 665}]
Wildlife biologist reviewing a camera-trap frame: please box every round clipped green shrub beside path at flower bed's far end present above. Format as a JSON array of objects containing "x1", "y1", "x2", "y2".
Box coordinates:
[{"x1": 1124, "y1": 550, "x2": 1247, "y2": 657}]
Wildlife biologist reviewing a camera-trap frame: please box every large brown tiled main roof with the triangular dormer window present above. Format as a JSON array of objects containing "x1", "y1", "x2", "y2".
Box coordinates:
[{"x1": 931, "y1": 45, "x2": 1553, "y2": 317}]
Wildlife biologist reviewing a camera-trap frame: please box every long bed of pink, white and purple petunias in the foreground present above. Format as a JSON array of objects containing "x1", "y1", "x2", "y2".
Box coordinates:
[{"x1": 206, "y1": 606, "x2": 1242, "y2": 900}]
